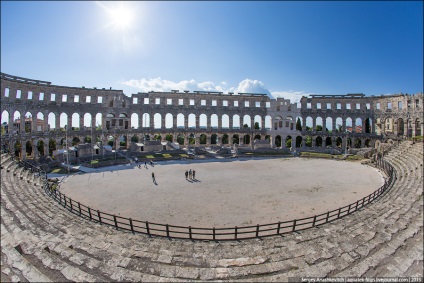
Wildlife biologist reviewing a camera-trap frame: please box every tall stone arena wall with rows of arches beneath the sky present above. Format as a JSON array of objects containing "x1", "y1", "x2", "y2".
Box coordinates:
[{"x1": 1, "y1": 73, "x2": 423, "y2": 158}]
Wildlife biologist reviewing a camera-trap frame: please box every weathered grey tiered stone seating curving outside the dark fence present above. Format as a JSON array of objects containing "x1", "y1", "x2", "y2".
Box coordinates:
[{"x1": 1, "y1": 143, "x2": 423, "y2": 282}]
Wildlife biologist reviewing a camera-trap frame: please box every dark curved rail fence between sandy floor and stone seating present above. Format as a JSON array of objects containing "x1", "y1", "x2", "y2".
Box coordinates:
[{"x1": 5, "y1": 151, "x2": 396, "y2": 241}]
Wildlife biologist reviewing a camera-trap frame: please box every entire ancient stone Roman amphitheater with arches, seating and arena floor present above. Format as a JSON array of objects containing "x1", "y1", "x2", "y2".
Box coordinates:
[{"x1": 1, "y1": 73, "x2": 424, "y2": 282}]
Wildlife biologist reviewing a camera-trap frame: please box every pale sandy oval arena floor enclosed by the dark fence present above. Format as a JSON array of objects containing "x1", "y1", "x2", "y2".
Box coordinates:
[{"x1": 60, "y1": 158, "x2": 384, "y2": 228}]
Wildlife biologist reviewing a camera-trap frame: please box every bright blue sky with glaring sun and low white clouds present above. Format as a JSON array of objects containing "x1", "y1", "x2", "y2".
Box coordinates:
[{"x1": 1, "y1": 1, "x2": 423, "y2": 101}]
